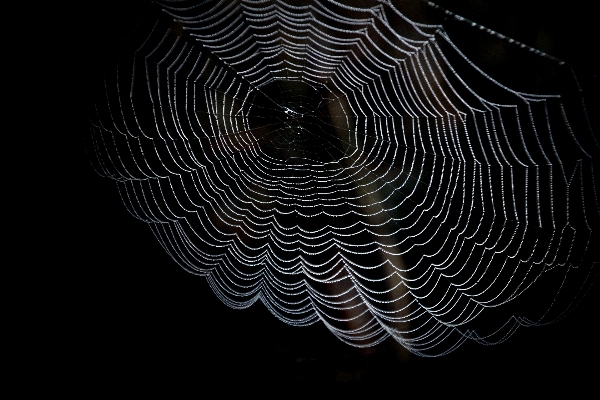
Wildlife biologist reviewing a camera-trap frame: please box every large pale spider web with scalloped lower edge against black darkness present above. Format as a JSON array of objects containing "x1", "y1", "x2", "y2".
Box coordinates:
[{"x1": 87, "y1": 0, "x2": 600, "y2": 355}]
